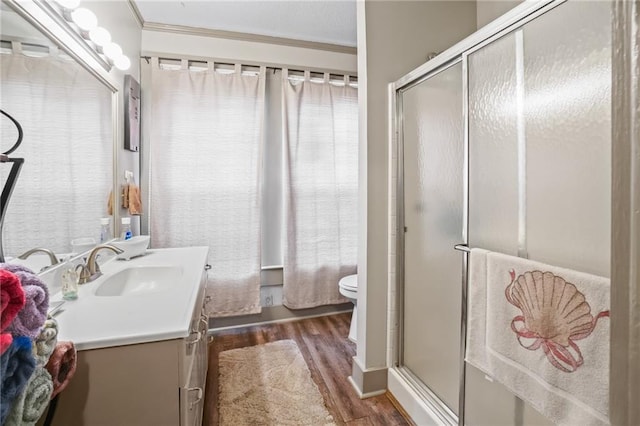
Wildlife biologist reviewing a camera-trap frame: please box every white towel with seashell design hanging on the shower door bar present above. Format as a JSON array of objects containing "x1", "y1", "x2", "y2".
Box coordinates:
[{"x1": 466, "y1": 249, "x2": 610, "y2": 426}]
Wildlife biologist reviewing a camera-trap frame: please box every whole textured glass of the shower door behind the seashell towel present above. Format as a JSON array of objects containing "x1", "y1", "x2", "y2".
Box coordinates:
[{"x1": 466, "y1": 2, "x2": 611, "y2": 425}]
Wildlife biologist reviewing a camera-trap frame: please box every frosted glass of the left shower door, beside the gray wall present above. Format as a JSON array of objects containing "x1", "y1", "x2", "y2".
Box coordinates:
[{"x1": 402, "y1": 64, "x2": 463, "y2": 411}]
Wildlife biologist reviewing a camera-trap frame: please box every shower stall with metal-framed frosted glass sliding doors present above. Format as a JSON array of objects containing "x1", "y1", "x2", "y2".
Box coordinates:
[{"x1": 389, "y1": 0, "x2": 613, "y2": 425}]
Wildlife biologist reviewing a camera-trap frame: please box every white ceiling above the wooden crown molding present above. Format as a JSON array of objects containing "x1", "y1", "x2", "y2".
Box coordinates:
[{"x1": 133, "y1": 0, "x2": 356, "y2": 47}]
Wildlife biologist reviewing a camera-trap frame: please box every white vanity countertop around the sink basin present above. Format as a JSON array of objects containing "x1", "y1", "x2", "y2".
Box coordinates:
[{"x1": 50, "y1": 247, "x2": 209, "y2": 350}]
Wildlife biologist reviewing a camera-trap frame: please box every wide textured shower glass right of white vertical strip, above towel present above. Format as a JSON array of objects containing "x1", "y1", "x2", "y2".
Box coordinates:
[{"x1": 524, "y1": 2, "x2": 611, "y2": 276}]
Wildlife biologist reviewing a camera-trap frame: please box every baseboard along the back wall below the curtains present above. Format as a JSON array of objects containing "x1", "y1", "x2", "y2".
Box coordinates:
[{"x1": 209, "y1": 302, "x2": 353, "y2": 333}]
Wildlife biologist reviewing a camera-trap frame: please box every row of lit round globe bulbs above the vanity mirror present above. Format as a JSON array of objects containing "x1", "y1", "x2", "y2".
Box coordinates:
[{"x1": 51, "y1": 0, "x2": 131, "y2": 71}]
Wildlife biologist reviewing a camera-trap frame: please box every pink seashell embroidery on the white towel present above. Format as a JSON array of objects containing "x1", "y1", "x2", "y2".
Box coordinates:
[{"x1": 505, "y1": 270, "x2": 609, "y2": 373}]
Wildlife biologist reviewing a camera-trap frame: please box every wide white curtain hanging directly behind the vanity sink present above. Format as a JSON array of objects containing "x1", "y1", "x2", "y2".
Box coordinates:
[{"x1": 149, "y1": 58, "x2": 265, "y2": 317}]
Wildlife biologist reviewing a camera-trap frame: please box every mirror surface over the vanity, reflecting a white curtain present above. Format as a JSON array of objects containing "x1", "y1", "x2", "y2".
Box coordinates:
[{"x1": 0, "y1": 3, "x2": 114, "y2": 258}]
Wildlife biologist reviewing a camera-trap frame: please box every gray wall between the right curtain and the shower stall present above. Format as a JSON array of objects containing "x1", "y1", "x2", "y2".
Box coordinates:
[{"x1": 353, "y1": 1, "x2": 476, "y2": 390}]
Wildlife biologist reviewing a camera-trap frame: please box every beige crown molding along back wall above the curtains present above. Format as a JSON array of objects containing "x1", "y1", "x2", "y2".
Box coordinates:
[{"x1": 142, "y1": 21, "x2": 357, "y2": 55}]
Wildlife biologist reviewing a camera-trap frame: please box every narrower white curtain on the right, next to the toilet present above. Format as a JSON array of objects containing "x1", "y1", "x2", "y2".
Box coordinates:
[{"x1": 283, "y1": 72, "x2": 358, "y2": 309}]
